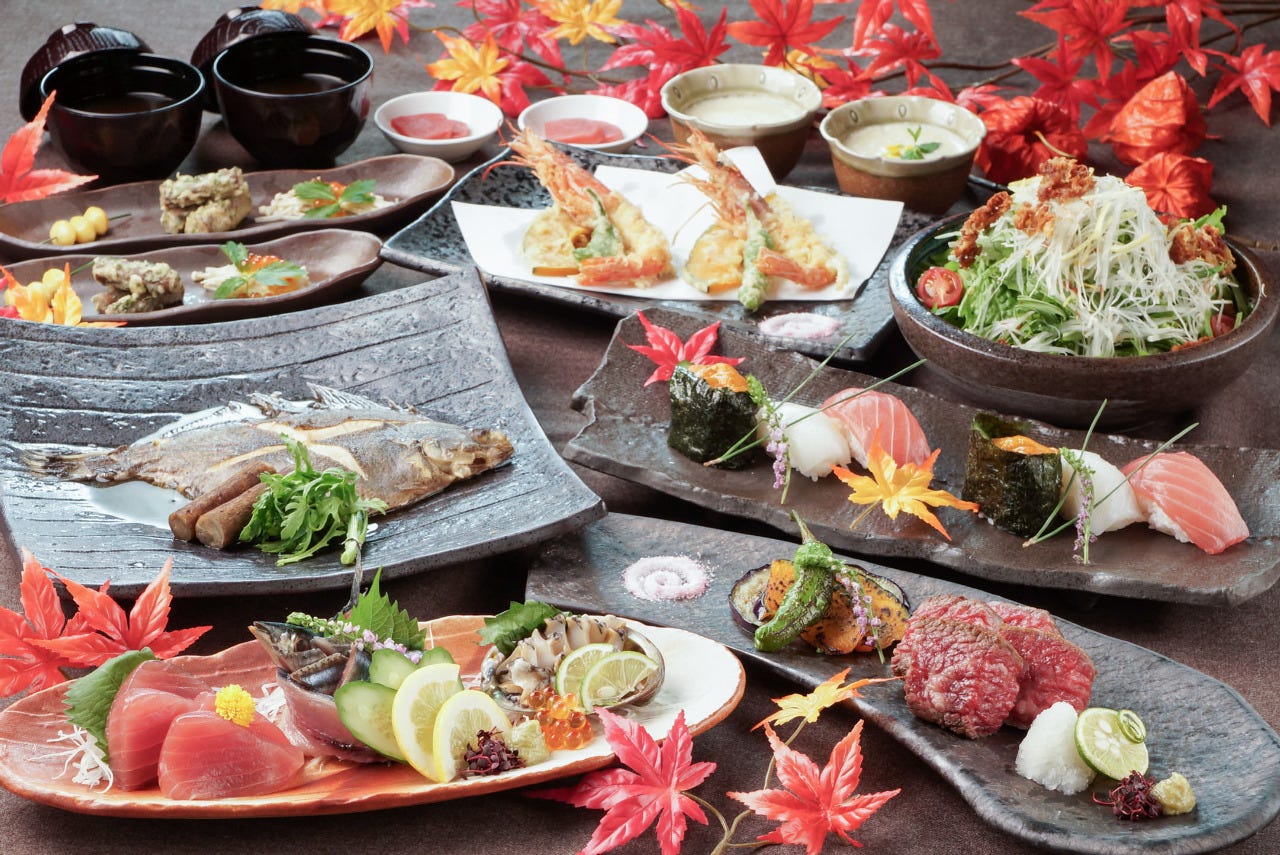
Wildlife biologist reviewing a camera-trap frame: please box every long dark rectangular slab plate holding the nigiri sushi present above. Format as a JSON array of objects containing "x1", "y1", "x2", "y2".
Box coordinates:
[{"x1": 564, "y1": 308, "x2": 1280, "y2": 603}]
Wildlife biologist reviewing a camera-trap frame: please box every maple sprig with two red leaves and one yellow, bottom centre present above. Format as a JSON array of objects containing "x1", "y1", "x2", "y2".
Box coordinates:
[{"x1": 529, "y1": 668, "x2": 901, "y2": 855}]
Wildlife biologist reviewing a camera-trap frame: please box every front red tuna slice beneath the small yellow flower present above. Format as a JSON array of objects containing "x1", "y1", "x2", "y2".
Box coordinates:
[{"x1": 160, "y1": 709, "x2": 306, "y2": 799}]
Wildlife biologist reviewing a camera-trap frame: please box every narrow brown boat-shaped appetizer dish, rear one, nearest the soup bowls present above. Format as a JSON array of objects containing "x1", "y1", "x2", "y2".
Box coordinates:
[{"x1": 0, "y1": 155, "x2": 455, "y2": 261}]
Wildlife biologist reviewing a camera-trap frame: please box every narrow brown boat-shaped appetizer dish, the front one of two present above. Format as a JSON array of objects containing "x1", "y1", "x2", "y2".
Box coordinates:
[{"x1": 8, "y1": 229, "x2": 383, "y2": 326}]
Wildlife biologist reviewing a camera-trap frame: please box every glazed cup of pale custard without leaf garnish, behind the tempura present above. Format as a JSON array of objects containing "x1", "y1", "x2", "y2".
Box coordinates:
[{"x1": 662, "y1": 64, "x2": 822, "y2": 179}]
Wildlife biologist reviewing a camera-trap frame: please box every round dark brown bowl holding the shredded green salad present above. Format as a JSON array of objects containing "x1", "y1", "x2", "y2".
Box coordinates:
[{"x1": 890, "y1": 214, "x2": 1280, "y2": 429}]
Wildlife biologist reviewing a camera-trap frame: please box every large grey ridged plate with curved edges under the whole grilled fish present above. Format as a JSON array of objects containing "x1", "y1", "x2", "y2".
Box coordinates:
[{"x1": 0, "y1": 267, "x2": 604, "y2": 596}]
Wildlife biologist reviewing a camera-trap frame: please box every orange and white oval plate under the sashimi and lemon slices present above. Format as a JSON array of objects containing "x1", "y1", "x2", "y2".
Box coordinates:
[{"x1": 0, "y1": 614, "x2": 746, "y2": 819}]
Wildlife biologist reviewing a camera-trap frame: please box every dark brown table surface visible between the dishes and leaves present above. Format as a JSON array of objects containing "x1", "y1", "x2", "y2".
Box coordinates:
[{"x1": 0, "y1": 0, "x2": 1280, "y2": 855}]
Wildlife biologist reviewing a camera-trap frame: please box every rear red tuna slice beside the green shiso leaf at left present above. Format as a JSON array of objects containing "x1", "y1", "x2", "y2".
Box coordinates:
[{"x1": 106, "y1": 686, "x2": 200, "y2": 790}]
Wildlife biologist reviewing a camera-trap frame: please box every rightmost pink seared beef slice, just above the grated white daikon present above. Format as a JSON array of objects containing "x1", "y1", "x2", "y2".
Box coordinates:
[{"x1": 1000, "y1": 623, "x2": 1097, "y2": 730}]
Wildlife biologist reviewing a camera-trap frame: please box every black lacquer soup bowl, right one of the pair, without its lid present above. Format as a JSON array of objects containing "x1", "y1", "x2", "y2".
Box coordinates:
[{"x1": 212, "y1": 33, "x2": 374, "y2": 168}]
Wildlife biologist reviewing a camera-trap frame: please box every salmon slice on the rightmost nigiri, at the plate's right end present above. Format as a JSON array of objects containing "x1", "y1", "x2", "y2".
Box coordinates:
[{"x1": 1123, "y1": 452, "x2": 1249, "y2": 555}]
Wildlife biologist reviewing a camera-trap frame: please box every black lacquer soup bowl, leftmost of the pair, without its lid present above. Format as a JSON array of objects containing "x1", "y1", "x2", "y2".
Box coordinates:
[{"x1": 40, "y1": 50, "x2": 205, "y2": 183}]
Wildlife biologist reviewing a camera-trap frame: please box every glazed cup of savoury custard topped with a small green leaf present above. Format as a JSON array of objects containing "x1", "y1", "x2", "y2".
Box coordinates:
[{"x1": 819, "y1": 95, "x2": 987, "y2": 214}]
